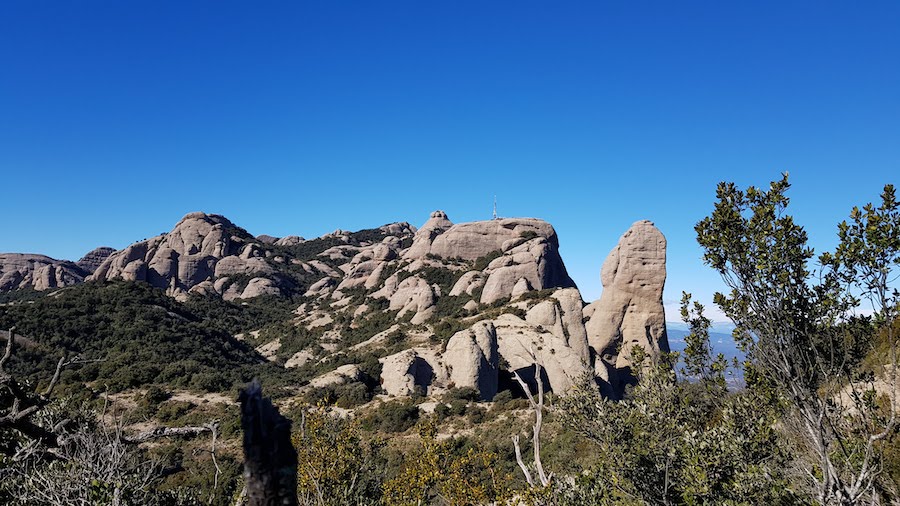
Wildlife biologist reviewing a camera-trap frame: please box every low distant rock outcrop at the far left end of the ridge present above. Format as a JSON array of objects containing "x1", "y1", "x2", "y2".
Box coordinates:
[{"x1": 0, "y1": 253, "x2": 90, "y2": 292}]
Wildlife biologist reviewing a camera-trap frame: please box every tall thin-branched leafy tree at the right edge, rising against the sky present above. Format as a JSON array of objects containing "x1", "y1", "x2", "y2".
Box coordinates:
[{"x1": 696, "y1": 175, "x2": 900, "y2": 505}]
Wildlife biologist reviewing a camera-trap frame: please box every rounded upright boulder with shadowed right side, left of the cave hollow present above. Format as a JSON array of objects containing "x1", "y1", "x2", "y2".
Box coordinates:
[{"x1": 443, "y1": 321, "x2": 500, "y2": 401}]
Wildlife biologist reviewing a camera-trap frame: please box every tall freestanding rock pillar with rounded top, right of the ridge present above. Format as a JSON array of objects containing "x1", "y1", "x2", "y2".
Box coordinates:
[{"x1": 585, "y1": 220, "x2": 669, "y2": 397}]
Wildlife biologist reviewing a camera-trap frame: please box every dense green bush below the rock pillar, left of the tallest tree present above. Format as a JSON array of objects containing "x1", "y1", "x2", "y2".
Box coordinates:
[{"x1": 559, "y1": 294, "x2": 797, "y2": 505}]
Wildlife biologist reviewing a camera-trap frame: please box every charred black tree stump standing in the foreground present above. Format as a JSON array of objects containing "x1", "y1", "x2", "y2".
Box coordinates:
[{"x1": 240, "y1": 380, "x2": 297, "y2": 506}]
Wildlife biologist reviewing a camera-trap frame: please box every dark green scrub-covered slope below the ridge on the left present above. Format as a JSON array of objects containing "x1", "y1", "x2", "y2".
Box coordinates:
[{"x1": 0, "y1": 281, "x2": 284, "y2": 392}]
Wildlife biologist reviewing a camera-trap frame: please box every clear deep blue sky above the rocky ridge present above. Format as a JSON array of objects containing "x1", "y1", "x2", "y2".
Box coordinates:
[{"x1": 0, "y1": 0, "x2": 900, "y2": 317}]
